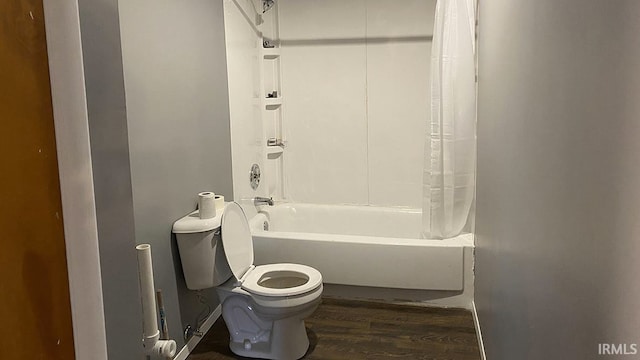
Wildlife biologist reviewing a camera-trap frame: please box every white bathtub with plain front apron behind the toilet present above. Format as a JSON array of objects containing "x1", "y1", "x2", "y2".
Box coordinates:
[{"x1": 250, "y1": 203, "x2": 473, "y2": 291}]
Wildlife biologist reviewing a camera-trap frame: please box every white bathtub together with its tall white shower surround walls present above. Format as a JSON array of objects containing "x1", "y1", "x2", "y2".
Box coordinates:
[{"x1": 224, "y1": 0, "x2": 473, "y2": 308}]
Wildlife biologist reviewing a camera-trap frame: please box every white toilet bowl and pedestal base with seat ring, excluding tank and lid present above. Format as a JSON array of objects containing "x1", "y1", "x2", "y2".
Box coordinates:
[{"x1": 216, "y1": 264, "x2": 322, "y2": 359}]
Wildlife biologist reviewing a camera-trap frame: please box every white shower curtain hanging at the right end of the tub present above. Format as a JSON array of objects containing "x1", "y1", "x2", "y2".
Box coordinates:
[{"x1": 422, "y1": 0, "x2": 476, "y2": 239}]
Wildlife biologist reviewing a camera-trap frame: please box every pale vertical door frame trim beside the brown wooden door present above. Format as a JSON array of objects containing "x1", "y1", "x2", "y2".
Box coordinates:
[{"x1": 43, "y1": 0, "x2": 107, "y2": 360}]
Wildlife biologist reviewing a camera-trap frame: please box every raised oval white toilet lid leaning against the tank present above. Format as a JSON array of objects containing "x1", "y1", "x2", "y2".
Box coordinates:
[{"x1": 221, "y1": 202, "x2": 253, "y2": 280}]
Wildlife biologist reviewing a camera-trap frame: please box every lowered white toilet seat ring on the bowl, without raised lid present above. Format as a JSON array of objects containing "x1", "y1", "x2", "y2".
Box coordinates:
[{"x1": 241, "y1": 264, "x2": 322, "y2": 296}]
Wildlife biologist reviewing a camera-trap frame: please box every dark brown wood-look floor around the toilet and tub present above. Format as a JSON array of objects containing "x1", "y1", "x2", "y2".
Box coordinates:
[{"x1": 188, "y1": 298, "x2": 480, "y2": 360}]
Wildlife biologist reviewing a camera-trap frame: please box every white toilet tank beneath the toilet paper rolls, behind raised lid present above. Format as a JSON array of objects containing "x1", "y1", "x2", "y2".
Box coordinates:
[{"x1": 173, "y1": 211, "x2": 232, "y2": 290}]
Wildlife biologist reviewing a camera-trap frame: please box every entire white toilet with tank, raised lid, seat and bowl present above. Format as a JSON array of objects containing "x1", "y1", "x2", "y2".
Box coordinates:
[{"x1": 173, "y1": 202, "x2": 322, "y2": 360}]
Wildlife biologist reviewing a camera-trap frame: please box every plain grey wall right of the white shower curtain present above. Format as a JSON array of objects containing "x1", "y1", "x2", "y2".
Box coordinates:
[{"x1": 476, "y1": 0, "x2": 640, "y2": 360}]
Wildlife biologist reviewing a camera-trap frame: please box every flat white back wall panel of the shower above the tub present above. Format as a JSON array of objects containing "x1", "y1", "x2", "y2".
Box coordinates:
[{"x1": 278, "y1": 0, "x2": 435, "y2": 208}]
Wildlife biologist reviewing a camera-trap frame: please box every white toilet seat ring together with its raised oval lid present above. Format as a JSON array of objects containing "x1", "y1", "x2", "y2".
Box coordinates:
[{"x1": 221, "y1": 202, "x2": 322, "y2": 297}]
